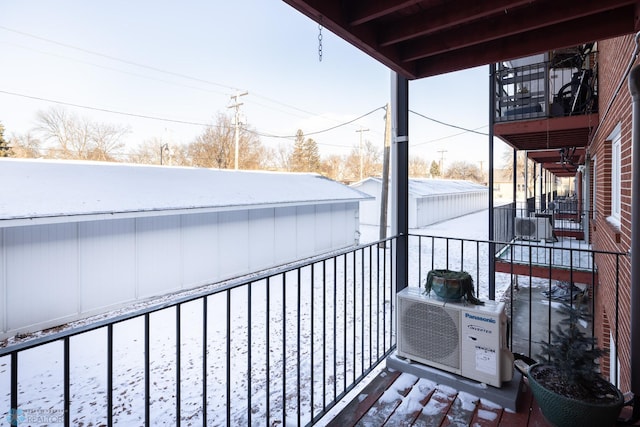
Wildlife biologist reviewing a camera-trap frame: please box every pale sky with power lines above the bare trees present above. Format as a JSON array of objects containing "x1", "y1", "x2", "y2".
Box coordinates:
[{"x1": 0, "y1": 0, "x2": 510, "y2": 169}]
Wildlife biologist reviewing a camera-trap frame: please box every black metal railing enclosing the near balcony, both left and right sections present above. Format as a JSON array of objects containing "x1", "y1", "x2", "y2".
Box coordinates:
[{"x1": 0, "y1": 235, "x2": 626, "y2": 426}]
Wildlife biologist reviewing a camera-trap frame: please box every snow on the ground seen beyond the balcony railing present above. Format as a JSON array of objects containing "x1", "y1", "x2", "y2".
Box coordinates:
[{"x1": 0, "y1": 206, "x2": 544, "y2": 425}]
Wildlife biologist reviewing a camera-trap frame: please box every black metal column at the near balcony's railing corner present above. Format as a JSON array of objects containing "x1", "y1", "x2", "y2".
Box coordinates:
[{"x1": 391, "y1": 73, "x2": 409, "y2": 292}]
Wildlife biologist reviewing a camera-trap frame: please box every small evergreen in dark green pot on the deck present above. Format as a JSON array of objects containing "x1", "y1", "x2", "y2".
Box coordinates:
[{"x1": 527, "y1": 303, "x2": 624, "y2": 427}]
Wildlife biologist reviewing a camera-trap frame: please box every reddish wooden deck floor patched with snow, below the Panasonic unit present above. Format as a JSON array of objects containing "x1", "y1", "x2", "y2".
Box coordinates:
[{"x1": 327, "y1": 369, "x2": 638, "y2": 427}]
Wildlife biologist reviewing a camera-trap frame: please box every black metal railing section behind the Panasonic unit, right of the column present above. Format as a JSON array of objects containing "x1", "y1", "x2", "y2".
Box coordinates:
[{"x1": 409, "y1": 235, "x2": 628, "y2": 385}]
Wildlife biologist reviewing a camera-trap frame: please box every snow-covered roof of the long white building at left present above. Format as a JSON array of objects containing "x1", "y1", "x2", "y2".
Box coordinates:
[{"x1": 0, "y1": 159, "x2": 370, "y2": 227}]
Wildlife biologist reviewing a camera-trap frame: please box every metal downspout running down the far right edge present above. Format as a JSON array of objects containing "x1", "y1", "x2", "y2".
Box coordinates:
[{"x1": 629, "y1": 66, "x2": 640, "y2": 422}]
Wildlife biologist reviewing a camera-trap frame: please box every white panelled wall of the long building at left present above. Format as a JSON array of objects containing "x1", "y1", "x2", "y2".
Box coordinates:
[{"x1": 0, "y1": 202, "x2": 359, "y2": 339}]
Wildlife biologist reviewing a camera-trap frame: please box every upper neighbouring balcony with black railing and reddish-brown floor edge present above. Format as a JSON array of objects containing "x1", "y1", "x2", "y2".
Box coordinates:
[{"x1": 494, "y1": 43, "x2": 599, "y2": 155}]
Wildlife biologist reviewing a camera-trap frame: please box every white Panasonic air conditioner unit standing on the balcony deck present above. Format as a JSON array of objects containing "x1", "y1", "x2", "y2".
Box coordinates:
[{"x1": 397, "y1": 287, "x2": 513, "y2": 387}]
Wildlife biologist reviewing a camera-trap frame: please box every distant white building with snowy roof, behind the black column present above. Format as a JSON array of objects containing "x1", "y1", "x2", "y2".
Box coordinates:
[{"x1": 352, "y1": 178, "x2": 489, "y2": 228}]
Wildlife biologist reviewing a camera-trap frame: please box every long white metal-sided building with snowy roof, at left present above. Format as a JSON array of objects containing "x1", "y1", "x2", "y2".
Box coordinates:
[{"x1": 0, "y1": 159, "x2": 367, "y2": 339}]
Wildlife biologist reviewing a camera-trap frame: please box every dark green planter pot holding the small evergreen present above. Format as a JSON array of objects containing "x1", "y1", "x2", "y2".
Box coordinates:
[{"x1": 527, "y1": 363, "x2": 624, "y2": 427}]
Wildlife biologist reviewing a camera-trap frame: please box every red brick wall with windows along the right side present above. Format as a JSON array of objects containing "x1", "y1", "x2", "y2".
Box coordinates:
[{"x1": 588, "y1": 35, "x2": 637, "y2": 392}]
